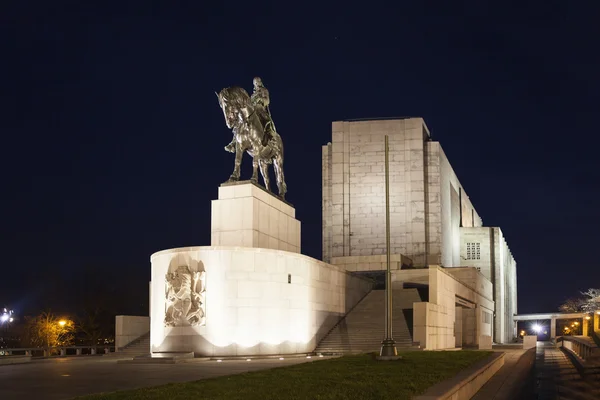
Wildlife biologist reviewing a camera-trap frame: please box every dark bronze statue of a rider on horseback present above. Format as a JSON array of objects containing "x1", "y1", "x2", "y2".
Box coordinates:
[{"x1": 217, "y1": 78, "x2": 287, "y2": 199}]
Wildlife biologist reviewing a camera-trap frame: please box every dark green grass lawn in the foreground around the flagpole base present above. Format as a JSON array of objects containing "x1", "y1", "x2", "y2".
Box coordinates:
[{"x1": 79, "y1": 351, "x2": 491, "y2": 400}]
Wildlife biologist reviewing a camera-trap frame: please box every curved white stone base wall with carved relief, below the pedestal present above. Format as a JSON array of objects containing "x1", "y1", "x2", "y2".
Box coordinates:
[{"x1": 150, "y1": 247, "x2": 372, "y2": 356}]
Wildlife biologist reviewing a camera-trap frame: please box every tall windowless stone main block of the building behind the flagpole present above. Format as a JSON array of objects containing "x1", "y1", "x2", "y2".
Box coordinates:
[{"x1": 322, "y1": 118, "x2": 482, "y2": 267}]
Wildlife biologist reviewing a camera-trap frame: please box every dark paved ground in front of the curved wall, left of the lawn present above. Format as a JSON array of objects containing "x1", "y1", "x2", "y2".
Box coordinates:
[{"x1": 0, "y1": 357, "x2": 328, "y2": 400}]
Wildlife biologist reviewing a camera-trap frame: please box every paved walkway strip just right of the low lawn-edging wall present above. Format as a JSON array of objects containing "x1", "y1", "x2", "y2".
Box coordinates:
[{"x1": 472, "y1": 348, "x2": 535, "y2": 400}]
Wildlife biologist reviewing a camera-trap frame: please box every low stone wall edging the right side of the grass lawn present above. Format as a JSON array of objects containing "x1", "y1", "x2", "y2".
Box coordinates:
[{"x1": 414, "y1": 353, "x2": 504, "y2": 400}]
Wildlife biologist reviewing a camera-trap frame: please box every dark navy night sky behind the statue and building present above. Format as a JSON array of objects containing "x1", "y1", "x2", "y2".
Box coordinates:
[{"x1": 0, "y1": 0, "x2": 600, "y2": 314}]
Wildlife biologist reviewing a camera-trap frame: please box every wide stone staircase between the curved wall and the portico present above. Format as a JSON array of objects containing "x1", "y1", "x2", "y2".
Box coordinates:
[{"x1": 315, "y1": 289, "x2": 423, "y2": 354}]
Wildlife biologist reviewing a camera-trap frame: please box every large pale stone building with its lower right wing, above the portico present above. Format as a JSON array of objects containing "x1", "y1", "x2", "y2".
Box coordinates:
[{"x1": 322, "y1": 118, "x2": 517, "y2": 343}]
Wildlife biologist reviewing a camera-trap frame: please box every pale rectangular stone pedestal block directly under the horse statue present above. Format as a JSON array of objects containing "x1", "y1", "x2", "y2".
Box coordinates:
[{"x1": 210, "y1": 181, "x2": 300, "y2": 253}]
